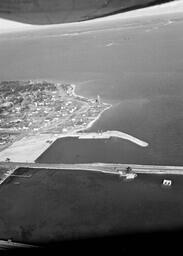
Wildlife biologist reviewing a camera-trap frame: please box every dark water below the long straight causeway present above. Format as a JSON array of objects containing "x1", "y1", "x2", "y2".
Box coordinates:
[{"x1": 0, "y1": 168, "x2": 183, "y2": 243}]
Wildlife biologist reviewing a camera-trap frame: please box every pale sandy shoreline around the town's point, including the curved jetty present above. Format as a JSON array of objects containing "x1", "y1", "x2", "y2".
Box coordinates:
[{"x1": 0, "y1": 83, "x2": 149, "y2": 163}]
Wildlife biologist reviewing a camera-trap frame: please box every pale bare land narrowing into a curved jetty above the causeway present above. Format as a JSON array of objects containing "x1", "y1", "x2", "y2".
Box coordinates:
[{"x1": 0, "y1": 131, "x2": 148, "y2": 163}]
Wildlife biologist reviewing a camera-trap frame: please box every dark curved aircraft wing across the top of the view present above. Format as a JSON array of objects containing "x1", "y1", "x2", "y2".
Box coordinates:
[{"x1": 0, "y1": 0, "x2": 177, "y2": 24}]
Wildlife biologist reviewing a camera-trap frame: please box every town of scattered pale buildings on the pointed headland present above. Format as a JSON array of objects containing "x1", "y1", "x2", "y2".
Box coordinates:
[{"x1": 0, "y1": 80, "x2": 110, "y2": 150}]
